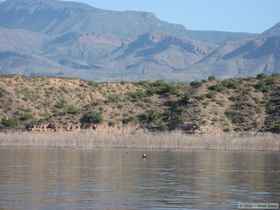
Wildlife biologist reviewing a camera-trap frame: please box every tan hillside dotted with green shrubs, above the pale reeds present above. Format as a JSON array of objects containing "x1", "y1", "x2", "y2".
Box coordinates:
[{"x1": 0, "y1": 75, "x2": 280, "y2": 135}]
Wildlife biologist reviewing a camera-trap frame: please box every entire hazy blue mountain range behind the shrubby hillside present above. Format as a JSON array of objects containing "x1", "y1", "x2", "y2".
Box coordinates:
[{"x1": 0, "y1": 0, "x2": 280, "y2": 81}]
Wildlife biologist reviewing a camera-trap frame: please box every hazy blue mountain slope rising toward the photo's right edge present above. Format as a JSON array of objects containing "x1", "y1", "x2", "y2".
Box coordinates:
[{"x1": 191, "y1": 24, "x2": 280, "y2": 78}]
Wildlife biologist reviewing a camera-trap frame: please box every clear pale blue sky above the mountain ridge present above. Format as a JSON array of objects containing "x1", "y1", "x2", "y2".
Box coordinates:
[{"x1": 76, "y1": 0, "x2": 280, "y2": 33}]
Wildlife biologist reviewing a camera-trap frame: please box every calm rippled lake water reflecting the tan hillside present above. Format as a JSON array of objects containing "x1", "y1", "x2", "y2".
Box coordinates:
[{"x1": 0, "y1": 148, "x2": 280, "y2": 210}]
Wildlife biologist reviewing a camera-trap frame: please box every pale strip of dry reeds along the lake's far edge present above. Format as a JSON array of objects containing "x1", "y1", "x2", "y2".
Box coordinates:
[{"x1": 0, "y1": 132, "x2": 280, "y2": 151}]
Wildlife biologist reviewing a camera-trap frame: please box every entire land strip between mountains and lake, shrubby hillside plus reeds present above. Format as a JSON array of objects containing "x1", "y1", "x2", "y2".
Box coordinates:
[{"x1": 0, "y1": 74, "x2": 280, "y2": 150}]
